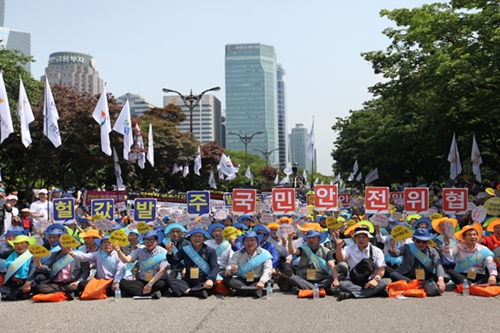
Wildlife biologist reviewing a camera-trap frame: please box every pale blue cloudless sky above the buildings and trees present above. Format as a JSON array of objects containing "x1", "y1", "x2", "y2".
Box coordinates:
[{"x1": 5, "y1": 0, "x2": 427, "y2": 175}]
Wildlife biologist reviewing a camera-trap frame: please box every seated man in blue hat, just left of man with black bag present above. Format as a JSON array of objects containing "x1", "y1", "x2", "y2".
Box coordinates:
[{"x1": 288, "y1": 230, "x2": 339, "y2": 295}]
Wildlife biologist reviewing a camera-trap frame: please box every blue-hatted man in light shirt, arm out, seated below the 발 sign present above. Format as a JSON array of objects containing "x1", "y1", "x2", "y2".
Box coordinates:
[{"x1": 113, "y1": 230, "x2": 168, "y2": 299}]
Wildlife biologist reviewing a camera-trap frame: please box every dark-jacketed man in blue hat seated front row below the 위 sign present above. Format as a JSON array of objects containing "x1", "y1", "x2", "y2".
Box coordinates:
[{"x1": 389, "y1": 228, "x2": 449, "y2": 296}]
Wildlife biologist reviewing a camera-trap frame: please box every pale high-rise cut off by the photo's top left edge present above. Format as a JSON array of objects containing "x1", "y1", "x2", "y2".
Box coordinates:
[{"x1": 0, "y1": 0, "x2": 31, "y2": 72}]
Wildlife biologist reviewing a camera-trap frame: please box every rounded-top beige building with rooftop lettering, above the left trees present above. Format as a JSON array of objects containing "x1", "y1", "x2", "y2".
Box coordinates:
[{"x1": 41, "y1": 52, "x2": 104, "y2": 96}]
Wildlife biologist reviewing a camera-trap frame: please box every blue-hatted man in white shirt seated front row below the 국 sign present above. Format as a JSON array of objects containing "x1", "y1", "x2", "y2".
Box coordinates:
[{"x1": 223, "y1": 231, "x2": 273, "y2": 298}]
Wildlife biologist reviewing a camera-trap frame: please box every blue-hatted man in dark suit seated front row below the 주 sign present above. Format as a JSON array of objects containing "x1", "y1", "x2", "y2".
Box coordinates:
[{"x1": 166, "y1": 228, "x2": 219, "y2": 298}]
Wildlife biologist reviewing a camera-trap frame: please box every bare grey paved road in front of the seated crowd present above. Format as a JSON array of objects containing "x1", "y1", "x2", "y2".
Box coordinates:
[{"x1": 0, "y1": 286, "x2": 500, "y2": 333}]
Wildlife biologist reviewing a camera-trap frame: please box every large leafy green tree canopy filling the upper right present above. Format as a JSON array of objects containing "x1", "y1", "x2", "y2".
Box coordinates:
[{"x1": 332, "y1": 0, "x2": 500, "y2": 184}]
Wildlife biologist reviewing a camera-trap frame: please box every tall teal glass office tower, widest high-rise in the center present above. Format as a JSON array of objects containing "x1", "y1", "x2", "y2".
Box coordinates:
[{"x1": 225, "y1": 43, "x2": 279, "y2": 167}]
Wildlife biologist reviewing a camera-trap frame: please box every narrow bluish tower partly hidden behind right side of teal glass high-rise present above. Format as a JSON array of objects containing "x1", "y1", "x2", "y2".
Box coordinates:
[{"x1": 276, "y1": 64, "x2": 288, "y2": 169}]
